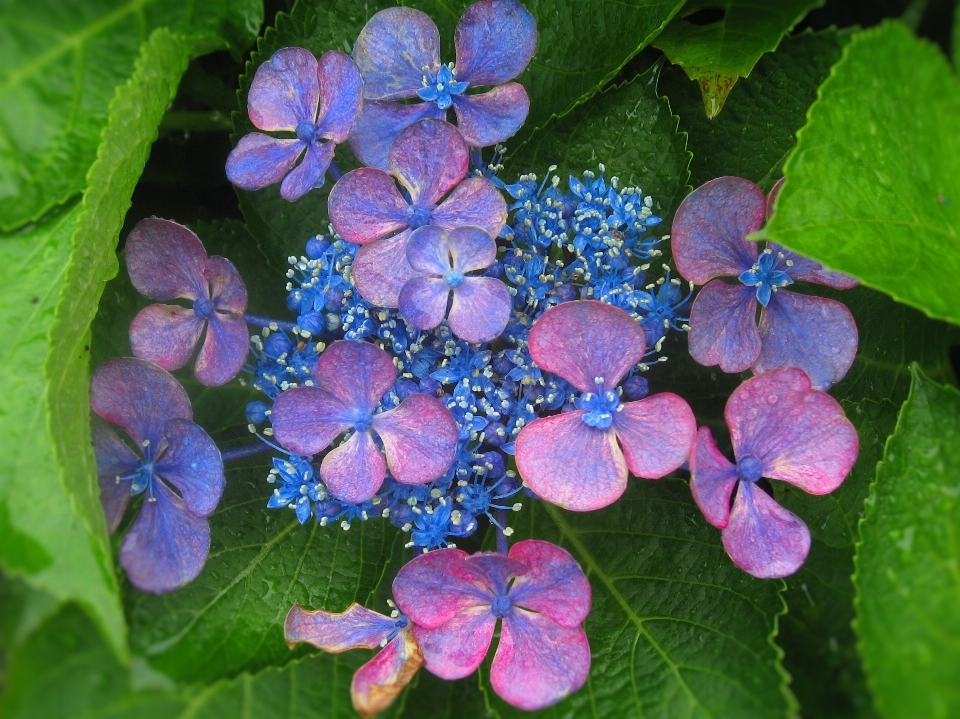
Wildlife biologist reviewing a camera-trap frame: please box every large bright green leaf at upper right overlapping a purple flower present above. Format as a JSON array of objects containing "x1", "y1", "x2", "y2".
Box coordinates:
[{"x1": 753, "y1": 22, "x2": 960, "y2": 323}]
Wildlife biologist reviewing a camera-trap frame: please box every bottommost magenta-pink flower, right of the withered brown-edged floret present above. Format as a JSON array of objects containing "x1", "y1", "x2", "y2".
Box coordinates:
[{"x1": 393, "y1": 539, "x2": 591, "y2": 710}]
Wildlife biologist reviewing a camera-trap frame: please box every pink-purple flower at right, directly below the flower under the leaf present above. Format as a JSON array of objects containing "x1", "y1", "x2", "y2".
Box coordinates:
[{"x1": 690, "y1": 367, "x2": 859, "y2": 579}]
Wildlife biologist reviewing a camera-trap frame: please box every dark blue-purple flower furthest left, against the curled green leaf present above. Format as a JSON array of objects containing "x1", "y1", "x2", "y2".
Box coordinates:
[{"x1": 90, "y1": 357, "x2": 225, "y2": 594}]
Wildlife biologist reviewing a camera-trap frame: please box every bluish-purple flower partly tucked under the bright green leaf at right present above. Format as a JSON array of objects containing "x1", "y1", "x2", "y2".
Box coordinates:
[{"x1": 671, "y1": 177, "x2": 858, "y2": 389}]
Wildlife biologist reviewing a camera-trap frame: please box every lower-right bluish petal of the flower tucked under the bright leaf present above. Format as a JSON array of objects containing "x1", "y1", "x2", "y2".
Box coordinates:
[{"x1": 751, "y1": 290, "x2": 859, "y2": 389}]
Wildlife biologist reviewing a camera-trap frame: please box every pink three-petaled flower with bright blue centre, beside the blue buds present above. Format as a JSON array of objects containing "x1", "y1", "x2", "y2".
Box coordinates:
[{"x1": 516, "y1": 300, "x2": 697, "y2": 511}]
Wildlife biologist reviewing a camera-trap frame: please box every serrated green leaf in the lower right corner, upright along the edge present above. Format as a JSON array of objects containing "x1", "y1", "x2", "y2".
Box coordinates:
[{"x1": 854, "y1": 367, "x2": 960, "y2": 719}]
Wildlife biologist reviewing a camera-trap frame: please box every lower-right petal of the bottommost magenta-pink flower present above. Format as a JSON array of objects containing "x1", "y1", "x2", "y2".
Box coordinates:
[{"x1": 490, "y1": 607, "x2": 590, "y2": 711}]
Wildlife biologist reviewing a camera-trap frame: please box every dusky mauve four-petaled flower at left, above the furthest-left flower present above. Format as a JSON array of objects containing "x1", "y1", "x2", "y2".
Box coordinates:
[{"x1": 126, "y1": 219, "x2": 249, "y2": 385}]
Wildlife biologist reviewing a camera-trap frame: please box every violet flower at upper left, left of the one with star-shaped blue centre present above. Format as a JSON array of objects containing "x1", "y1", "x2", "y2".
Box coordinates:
[{"x1": 227, "y1": 47, "x2": 362, "y2": 202}]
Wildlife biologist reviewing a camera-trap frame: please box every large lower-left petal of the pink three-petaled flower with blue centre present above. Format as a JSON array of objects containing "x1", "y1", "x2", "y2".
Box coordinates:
[{"x1": 515, "y1": 410, "x2": 627, "y2": 512}]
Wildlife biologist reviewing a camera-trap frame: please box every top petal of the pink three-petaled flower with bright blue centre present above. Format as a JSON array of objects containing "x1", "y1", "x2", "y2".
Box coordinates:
[{"x1": 530, "y1": 300, "x2": 646, "y2": 392}]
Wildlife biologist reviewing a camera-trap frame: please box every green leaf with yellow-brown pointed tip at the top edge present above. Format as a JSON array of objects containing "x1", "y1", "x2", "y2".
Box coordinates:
[{"x1": 654, "y1": 0, "x2": 824, "y2": 119}]
